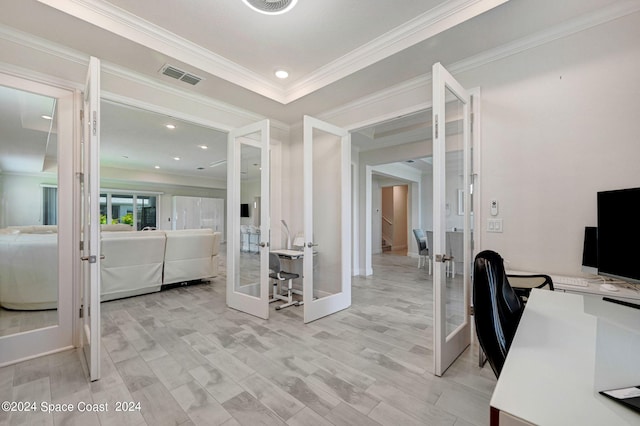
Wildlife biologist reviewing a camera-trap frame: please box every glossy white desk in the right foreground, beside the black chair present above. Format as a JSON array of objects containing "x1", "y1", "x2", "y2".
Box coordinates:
[{"x1": 491, "y1": 289, "x2": 640, "y2": 426}]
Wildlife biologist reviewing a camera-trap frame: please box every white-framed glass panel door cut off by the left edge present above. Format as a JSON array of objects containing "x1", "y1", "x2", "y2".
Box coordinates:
[{"x1": 0, "y1": 74, "x2": 77, "y2": 366}]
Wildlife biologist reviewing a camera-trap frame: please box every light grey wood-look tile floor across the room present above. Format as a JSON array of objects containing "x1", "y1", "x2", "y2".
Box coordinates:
[{"x1": 0, "y1": 254, "x2": 496, "y2": 426}]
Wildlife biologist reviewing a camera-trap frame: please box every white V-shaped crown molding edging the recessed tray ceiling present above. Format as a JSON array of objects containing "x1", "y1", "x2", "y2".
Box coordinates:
[{"x1": 38, "y1": 0, "x2": 508, "y2": 105}]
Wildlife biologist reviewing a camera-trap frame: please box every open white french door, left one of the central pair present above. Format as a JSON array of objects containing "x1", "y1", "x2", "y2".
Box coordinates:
[{"x1": 227, "y1": 120, "x2": 270, "y2": 319}]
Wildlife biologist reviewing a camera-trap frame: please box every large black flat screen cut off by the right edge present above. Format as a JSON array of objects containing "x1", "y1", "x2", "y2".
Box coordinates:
[{"x1": 597, "y1": 188, "x2": 640, "y2": 283}]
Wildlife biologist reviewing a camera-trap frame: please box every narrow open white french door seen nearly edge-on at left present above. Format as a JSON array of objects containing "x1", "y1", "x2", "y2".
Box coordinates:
[{"x1": 81, "y1": 57, "x2": 101, "y2": 381}]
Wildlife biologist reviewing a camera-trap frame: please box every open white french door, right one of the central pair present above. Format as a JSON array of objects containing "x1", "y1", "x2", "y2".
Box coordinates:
[{"x1": 303, "y1": 116, "x2": 351, "y2": 323}]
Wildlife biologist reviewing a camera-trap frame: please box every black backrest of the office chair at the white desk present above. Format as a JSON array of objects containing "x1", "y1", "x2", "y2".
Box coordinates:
[{"x1": 473, "y1": 250, "x2": 524, "y2": 377}]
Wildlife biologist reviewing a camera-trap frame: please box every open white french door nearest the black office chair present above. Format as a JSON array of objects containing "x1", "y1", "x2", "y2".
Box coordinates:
[{"x1": 433, "y1": 63, "x2": 471, "y2": 376}]
